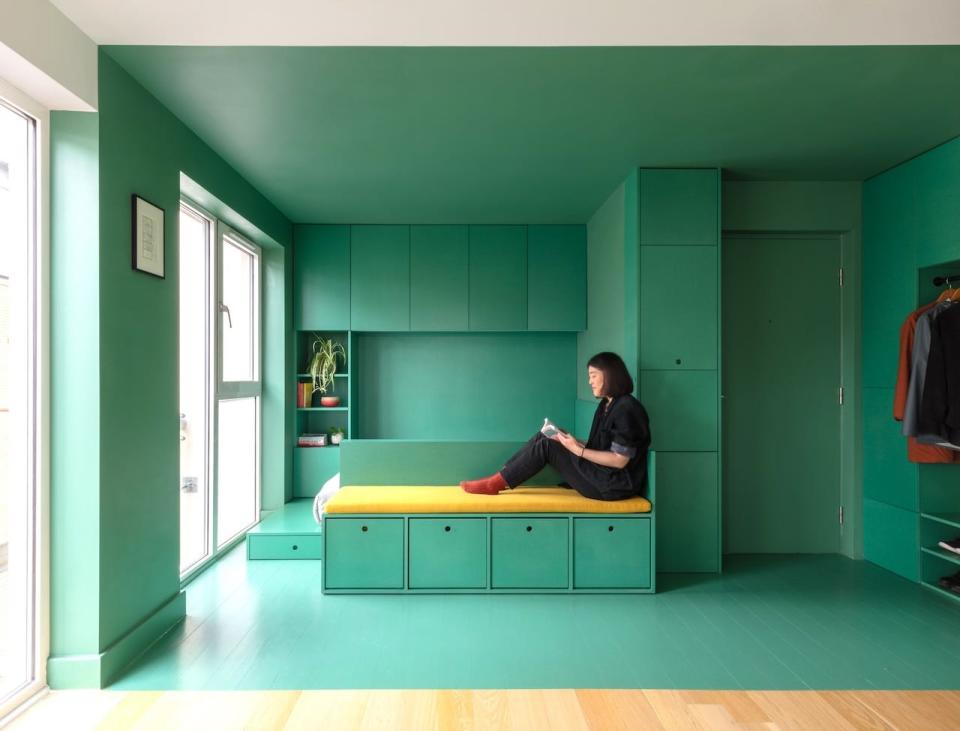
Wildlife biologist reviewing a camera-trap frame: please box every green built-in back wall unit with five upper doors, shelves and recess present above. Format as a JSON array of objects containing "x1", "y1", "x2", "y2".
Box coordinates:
[{"x1": 293, "y1": 225, "x2": 587, "y2": 497}]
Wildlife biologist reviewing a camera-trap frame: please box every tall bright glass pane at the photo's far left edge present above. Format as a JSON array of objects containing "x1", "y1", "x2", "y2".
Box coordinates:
[{"x1": 0, "y1": 104, "x2": 36, "y2": 699}]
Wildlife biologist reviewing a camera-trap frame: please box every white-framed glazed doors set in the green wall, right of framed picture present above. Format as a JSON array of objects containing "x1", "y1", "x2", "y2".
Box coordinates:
[{"x1": 180, "y1": 204, "x2": 261, "y2": 576}]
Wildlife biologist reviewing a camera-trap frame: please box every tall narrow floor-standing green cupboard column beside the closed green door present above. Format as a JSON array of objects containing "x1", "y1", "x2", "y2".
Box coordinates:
[{"x1": 625, "y1": 168, "x2": 721, "y2": 572}]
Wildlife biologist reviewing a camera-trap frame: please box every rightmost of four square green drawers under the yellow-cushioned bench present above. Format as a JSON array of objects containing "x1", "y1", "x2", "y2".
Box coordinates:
[{"x1": 573, "y1": 518, "x2": 650, "y2": 589}]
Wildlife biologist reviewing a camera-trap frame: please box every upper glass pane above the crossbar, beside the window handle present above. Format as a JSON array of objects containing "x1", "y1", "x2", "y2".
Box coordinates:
[{"x1": 220, "y1": 237, "x2": 257, "y2": 381}]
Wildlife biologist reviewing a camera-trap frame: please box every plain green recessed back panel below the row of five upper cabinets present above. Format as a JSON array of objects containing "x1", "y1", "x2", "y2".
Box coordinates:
[{"x1": 353, "y1": 333, "x2": 582, "y2": 441}]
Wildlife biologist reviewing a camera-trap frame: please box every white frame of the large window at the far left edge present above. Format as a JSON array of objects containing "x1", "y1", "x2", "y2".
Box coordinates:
[{"x1": 0, "y1": 79, "x2": 50, "y2": 721}]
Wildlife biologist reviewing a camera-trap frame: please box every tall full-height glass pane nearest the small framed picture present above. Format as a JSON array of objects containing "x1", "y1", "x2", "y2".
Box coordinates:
[{"x1": 180, "y1": 210, "x2": 211, "y2": 573}]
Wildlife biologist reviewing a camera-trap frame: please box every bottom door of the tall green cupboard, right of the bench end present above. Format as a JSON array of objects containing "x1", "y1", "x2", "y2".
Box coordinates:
[{"x1": 656, "y1": 452, "x2": 720, "y2": 572}]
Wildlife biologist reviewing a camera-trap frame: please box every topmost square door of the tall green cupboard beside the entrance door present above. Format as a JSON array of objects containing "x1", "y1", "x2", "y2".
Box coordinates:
[{"x1": 640, "y1": 169, "x2": 720, "y2": 246}]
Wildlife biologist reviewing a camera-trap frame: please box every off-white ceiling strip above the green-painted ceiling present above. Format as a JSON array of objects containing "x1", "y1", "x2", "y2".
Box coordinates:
[{"x1": 52, "y1": 0, "x2": 960, "y2": 46}]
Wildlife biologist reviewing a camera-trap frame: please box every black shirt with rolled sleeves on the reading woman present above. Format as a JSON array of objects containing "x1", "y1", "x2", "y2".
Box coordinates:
[{"x1": 587, "y1": 394, "x2": 650, "y2": 494}]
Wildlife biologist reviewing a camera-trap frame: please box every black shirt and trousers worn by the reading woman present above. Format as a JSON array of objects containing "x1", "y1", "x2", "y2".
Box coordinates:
[{"x1": 500, "y1": 396, "x2": 650, "y2": 500}]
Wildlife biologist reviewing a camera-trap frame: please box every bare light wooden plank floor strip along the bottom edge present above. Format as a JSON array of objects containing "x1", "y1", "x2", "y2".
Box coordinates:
[{"x1": 9, "y1": 690, "x2": 960, "y2": 731}]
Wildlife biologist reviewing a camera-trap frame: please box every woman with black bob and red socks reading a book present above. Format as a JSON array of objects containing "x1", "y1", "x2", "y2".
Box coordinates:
[{"x1": 460, "y1": 353, "x2": 650, "y2": 500}]
